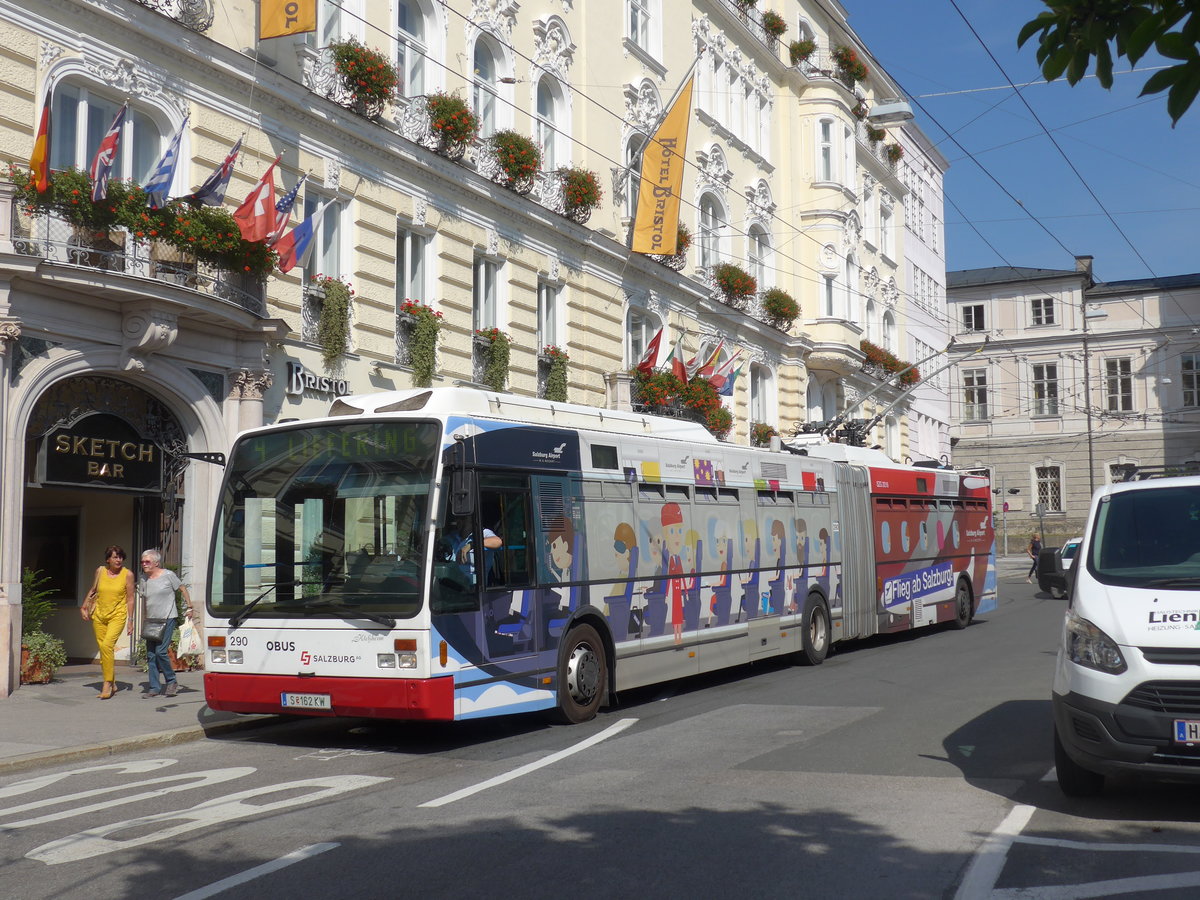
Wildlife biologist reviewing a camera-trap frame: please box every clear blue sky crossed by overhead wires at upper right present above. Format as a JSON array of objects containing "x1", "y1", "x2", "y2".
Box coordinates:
[{"x1": 842, "y1": 0, "x2": 1200, "y2": 281}]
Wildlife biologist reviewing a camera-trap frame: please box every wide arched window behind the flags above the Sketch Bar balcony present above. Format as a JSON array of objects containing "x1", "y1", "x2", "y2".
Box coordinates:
[{"x1": 50, "y1": 82, "x2": 162, "y2": 185}]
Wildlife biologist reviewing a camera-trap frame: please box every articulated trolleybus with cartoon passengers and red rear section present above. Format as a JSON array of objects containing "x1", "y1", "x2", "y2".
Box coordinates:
[{"x1": 204, "y1": 388, "x2": 996, "y2": 721}]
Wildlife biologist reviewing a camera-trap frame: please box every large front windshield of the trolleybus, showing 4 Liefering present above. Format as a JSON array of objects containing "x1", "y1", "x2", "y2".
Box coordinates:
[{"x1": 210, "y1": 421, "x2": 442, "y2": 620}]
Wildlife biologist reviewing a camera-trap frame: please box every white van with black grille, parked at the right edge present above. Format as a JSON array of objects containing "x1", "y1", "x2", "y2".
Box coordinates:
[{"x1": 1052, "y1": 476, "x2": 1200, "y2": 796}]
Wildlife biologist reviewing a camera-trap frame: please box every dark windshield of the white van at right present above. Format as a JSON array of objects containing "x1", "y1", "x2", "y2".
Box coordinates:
[{"x1": 1087, "y1": 485, "x2": 1200, "y2": 590}]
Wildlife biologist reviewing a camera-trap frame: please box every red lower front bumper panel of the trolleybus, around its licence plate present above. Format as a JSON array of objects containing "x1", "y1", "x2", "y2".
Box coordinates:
[{"x1": 204, "y1": 672, "x2": 454, "y2": 720}]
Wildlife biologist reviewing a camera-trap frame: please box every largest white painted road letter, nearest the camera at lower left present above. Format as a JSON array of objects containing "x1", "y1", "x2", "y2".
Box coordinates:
[{"x1": 25, "y1": 775, "x2": 391, "y2": 865}]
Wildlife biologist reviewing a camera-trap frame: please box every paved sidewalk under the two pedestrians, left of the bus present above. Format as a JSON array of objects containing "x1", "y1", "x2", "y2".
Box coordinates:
[{"x1": 0, "y1": 664, "x2": 278, "y2": 775}]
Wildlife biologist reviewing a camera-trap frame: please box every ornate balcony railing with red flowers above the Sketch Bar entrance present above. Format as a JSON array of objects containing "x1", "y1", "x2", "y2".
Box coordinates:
[{"x1": 11, "y1": 203, "x2": 266, "y2": 316}]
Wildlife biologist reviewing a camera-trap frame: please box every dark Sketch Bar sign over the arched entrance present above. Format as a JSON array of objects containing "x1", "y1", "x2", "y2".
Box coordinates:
[{"x1": 38, "y1": 413, "x2": 162, "y2": 491}]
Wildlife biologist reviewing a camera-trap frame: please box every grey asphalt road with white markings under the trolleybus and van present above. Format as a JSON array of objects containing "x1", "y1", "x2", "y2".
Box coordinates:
[{"x1": 0, "y1": 575, "x2": 1200, "y2": 900}]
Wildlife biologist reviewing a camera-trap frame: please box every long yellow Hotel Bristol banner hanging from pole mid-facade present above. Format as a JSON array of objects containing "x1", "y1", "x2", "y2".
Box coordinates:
[{"x1": 632, "y1": 78, "x2": 694, "y2": 256}]
